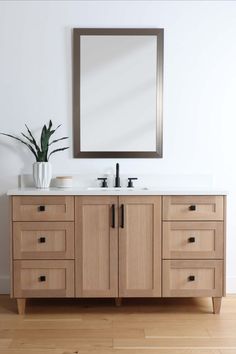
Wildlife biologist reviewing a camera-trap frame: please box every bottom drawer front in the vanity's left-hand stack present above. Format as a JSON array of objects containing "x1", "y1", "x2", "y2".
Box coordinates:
[{"x1": 14, "y1": 260, "x2": 74, "y2": 298}]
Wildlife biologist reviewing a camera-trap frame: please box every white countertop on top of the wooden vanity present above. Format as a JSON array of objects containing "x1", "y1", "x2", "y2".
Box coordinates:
[{"x1": 7, "y1": 187, "x2": 228, "y2": 196}]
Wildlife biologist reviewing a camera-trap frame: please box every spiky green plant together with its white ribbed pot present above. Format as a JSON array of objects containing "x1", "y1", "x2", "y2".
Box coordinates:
[{"x1": 0, "y1": 120, "x2": 69, "y2": 188}]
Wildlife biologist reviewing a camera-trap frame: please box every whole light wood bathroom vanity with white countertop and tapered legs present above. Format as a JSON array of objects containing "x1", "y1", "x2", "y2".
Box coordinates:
[{"x1": 8, "y1": 188, "x2": 226, "y2": 314}]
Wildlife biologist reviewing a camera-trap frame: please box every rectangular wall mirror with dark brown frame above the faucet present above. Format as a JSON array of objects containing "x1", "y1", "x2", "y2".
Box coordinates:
[{"x1": 73, "y1": 28, "x2": 163, "y2": 158}]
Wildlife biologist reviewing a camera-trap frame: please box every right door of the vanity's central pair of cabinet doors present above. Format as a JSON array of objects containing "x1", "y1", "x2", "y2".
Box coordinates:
[{"x1": 119, "y1": 196, "x2": 161, "y2": 297}]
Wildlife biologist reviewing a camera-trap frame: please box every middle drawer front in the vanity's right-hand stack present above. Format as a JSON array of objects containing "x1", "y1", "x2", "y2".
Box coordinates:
[{"x1": 162, "y1": 221, "x2": 224, "y2": 259}]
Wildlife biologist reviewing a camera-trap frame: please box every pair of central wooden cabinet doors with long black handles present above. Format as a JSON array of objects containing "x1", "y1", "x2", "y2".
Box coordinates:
[{"x1": 75, "y1": 196, "x2": 161, "y2": 297}]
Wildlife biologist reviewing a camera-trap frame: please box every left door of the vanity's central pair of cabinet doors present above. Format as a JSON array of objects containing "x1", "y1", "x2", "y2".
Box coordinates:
[{"x1": 75, "y1": 196, "x2": 118, "y2": 297}]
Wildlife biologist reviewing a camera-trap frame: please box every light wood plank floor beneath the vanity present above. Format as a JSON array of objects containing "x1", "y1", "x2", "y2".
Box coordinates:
[{"x1": 0, "y1": 295, "x2": 236, "y2": 354}]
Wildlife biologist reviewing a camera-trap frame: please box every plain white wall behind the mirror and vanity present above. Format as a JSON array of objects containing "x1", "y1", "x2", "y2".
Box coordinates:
[{"x1": 0, "y1": 1, "x2": 236, "y2": 292}]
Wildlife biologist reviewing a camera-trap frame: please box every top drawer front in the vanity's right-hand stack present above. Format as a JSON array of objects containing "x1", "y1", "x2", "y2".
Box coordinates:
[{"x1": 163, "y1": 196, "x2": 224, "y2": 221}]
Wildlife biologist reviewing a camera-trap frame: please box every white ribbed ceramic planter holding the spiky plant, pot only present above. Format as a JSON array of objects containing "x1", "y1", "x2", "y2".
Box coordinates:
[{"x1": 33, "y1": 162, "x2": 52, "y2": 188}]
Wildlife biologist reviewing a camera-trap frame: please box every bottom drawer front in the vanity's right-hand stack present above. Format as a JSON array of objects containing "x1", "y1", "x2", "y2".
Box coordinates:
[{"x1": 162, "y1": 260, "x2": 223, "y2": 297}]
